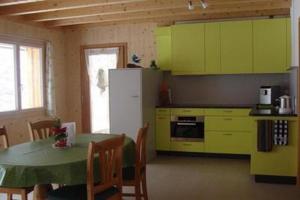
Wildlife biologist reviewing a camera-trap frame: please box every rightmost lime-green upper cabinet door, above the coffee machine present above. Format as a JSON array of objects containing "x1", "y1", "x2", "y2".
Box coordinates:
[{"x1": 253, "y1": 18, "x2": 288, "y2": 73}]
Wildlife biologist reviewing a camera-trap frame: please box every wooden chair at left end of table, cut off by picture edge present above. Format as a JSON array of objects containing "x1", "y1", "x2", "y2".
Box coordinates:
[{"x1": 0, "y1": 126, "x2": 33, "y2": 200}]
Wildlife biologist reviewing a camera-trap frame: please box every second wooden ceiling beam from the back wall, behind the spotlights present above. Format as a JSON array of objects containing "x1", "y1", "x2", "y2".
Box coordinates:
[{"x1": 24, "y1": 0, "x2": 290, "y2": 21}]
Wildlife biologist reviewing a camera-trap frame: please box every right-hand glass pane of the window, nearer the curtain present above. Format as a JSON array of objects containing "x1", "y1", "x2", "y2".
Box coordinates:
[{"x1": 20, "y1": 46, "x2": 43, "y2": 109}]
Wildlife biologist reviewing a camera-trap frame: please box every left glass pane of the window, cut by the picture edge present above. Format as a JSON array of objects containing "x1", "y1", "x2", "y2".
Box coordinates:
[{"x1": 0, "y1": 43, "x2": 17, "y2": 112}]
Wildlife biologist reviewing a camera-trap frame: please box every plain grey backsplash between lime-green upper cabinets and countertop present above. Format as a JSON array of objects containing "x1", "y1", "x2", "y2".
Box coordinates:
[{"x1": 164, "y1": 72, "x2": 290, "y2": 105}]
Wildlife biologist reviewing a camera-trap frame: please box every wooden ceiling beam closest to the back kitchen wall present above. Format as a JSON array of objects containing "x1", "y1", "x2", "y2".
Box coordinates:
[{"x1": 46, "y1": 2, "x2": 289, "y2": 26}]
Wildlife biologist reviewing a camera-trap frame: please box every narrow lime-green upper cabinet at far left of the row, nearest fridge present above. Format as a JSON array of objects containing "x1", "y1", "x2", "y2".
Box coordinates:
[{"x1": 155, "y1": 27, "x2": 172, "y2": 70}]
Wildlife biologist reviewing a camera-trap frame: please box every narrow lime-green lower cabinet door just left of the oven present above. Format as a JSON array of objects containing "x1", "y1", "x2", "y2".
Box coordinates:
[{"x1": 155, "y1": 112, "x2": 171, "y2": 151}]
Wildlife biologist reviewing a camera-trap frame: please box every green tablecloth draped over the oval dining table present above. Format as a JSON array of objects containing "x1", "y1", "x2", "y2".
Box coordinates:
[{"x1": 0, "y1": 134, "x2": 135, "y2": 187}]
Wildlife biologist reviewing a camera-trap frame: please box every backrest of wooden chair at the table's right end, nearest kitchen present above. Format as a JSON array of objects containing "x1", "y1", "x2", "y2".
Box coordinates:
[{"x1": 135, "y1": 123, "x2": 149, "y2": 175}]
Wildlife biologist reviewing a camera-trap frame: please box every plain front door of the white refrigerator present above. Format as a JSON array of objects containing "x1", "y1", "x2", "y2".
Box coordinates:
[{"x1": 109, "y1": 69, "x2": 143, "y2": 139}]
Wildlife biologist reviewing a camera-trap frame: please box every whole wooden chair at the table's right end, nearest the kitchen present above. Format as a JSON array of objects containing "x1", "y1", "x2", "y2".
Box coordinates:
[{"x1": 123, "y1": 123, "x2": 149, "y2": 200}]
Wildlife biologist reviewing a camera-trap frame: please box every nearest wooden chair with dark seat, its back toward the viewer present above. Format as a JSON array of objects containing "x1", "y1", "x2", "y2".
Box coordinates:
[{"x1": 47, "y1": 134, "x2": 125, "y2": 200}]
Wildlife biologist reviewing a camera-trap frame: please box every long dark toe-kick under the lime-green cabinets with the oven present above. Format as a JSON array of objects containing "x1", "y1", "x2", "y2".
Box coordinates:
[{"x1": 156, "y1": 151, "x2": 250, "y2": 160}]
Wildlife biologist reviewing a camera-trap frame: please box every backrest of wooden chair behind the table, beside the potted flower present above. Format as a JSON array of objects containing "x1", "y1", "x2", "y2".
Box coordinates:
[{"x1": 28, "y1": 120, "x2": 57, "y2": 141}]
